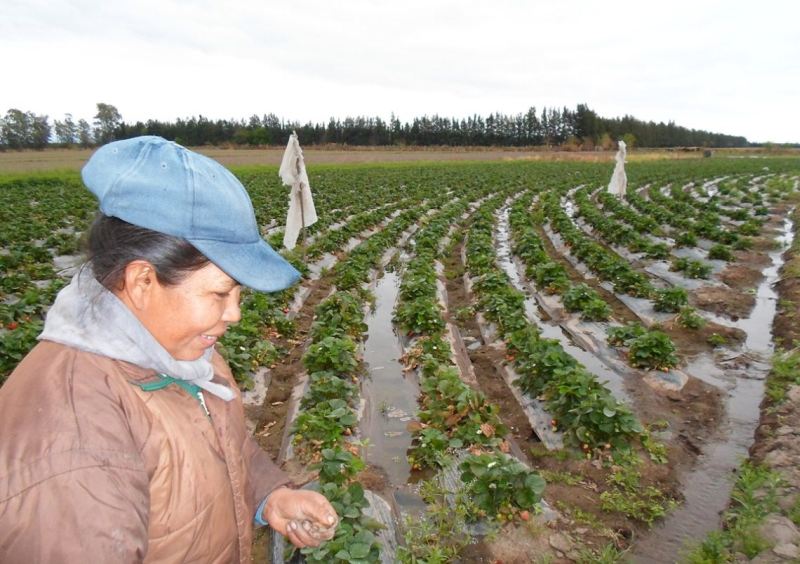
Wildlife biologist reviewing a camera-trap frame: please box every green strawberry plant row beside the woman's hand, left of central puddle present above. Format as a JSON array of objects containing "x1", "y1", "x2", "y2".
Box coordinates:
[{"x1": 292, "y1": 195, "x2": 456, "y2": 562}]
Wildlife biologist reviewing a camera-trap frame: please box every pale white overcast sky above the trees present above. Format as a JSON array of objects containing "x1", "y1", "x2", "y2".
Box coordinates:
[{"x1": 0, "y1": 0, "x2": 800, "y2": 143}]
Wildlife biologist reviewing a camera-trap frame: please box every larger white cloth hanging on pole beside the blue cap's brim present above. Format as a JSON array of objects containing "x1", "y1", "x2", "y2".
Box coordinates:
[{"x1": 278, "y1": 132, "x2": 317, "y2": 249}]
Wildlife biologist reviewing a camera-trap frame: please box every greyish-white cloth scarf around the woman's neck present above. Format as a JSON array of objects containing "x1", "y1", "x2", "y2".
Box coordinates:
[{"x1": 38, "y1": 266, "x2": 234, "y2": 401}]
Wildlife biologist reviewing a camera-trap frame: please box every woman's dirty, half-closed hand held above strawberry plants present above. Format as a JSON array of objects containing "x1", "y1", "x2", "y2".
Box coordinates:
[{"x1": 263, "y1": 488, "x2": 339, "y2": 548}]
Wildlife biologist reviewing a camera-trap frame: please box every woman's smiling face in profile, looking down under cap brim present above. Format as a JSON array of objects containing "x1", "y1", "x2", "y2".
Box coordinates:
[{"x1": 139, "y1": 263, "x2": 241, "y2": 360}]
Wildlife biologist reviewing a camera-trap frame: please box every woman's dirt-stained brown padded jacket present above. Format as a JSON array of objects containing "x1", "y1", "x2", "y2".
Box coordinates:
[{"x1": 0, "y1": 341, "x2": 288, "y2": 564}]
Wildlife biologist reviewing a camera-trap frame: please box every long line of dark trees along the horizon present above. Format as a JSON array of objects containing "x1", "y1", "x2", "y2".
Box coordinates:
[{"x1": 0, "y1": 103, "x2": 749, "y2": 150}]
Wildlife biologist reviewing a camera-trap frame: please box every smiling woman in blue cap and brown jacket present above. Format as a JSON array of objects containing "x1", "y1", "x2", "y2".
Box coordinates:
[{"x1": 0, "y1": 137, "x2": 337, "y2": 563}]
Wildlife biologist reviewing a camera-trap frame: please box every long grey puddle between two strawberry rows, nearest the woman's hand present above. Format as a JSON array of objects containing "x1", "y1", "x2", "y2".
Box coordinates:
[{"x1": 361, "y1": 272, "x2": 419, "y2": 487}]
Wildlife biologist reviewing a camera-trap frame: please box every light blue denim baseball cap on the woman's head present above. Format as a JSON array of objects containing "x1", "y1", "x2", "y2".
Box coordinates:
[{"x1": 81, "y1": 136, "x2": 300, "y2": 292}]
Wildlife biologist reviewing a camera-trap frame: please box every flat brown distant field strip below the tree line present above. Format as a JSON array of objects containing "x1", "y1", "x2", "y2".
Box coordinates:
[{"x1": 0, "y1": 147, "x2": 788, "y2": 173}]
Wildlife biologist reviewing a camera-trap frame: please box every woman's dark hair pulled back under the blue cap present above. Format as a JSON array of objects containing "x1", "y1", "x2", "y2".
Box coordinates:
[{"x1": 85, "y1": 212, "x2": 210, "y2": 291}]
